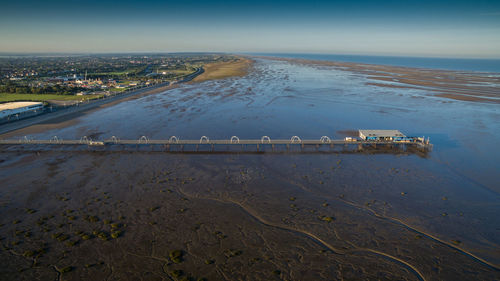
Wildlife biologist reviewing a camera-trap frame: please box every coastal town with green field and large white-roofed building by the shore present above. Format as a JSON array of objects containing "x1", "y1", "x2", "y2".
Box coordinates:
[{"x1": 0, "y1": 54, "x2": 237, "y2": 124}]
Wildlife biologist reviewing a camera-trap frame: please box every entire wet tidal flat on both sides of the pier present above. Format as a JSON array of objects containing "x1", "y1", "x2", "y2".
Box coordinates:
[{"x1": 0, "y1": 58, "x2": 500, "y2": 280}]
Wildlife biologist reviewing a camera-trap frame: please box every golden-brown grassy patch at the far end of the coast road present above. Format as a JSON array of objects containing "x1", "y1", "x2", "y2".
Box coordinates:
[{"x1": 193, "y1": 58, "x2": 252, "y2": 82}]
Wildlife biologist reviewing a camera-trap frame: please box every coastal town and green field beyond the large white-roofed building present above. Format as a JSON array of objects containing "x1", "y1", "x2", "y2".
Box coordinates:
[{"x1": 0, "y1": 54, "x2": 233, "y2": 102}]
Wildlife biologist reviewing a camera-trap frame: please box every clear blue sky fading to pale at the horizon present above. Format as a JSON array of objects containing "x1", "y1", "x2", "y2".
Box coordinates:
[{"x1": 0, "y1": 0, "x2": 500, "y2": 58}]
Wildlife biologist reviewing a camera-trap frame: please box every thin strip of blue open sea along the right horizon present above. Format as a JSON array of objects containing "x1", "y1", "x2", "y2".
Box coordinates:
[{"x1": 252, "y1": 53, "x2": 500, "y2": 73}]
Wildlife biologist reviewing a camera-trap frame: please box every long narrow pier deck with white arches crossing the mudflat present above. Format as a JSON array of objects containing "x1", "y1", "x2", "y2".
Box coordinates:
[{"x1": 0, "y1": 136, "x2": 432, "y2": 152}]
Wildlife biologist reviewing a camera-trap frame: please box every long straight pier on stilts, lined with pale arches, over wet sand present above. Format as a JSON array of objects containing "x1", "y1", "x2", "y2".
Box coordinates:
[{"x1": 0, "y1": 136, "x2": 432, "y2": 152}]
